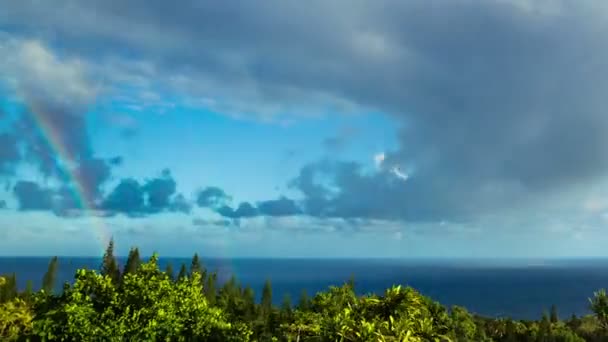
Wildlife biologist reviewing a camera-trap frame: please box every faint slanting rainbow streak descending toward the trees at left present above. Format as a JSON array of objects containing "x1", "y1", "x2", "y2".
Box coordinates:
[{"x1": 28, "y1": 101, "x2": 111, "y2": 255}]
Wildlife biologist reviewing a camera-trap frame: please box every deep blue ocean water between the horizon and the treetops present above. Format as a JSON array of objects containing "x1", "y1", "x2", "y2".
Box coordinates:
[{"x1": 0, "y1": 257, "x2": 608, "y2": 319}]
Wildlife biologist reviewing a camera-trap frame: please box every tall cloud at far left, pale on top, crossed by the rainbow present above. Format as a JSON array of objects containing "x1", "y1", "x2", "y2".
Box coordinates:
[{"x1": 0, "y1": 35, "x2": 120, "y2": 208}]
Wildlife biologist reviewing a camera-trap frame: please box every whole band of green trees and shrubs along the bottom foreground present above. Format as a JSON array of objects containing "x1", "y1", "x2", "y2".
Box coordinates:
[{"x1": 0, "y1": 239, "x2": 608, "y2": 342}]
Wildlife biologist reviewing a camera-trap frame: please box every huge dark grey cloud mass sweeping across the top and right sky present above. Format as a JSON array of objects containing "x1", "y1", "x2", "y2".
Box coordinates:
[{"x1": 0, "y1": 0, "x2": 608, "y2": 220}]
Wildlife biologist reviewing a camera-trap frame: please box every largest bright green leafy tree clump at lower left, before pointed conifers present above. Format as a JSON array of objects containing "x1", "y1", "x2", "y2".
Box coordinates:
[{"x1": 28, "y1": 252, "x2": 250, "y2": 341}]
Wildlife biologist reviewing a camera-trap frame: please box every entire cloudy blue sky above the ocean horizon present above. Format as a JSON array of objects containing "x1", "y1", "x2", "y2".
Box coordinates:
[{"x1": 0, "y1": 0, "x2": 608, "y2": 258}]
